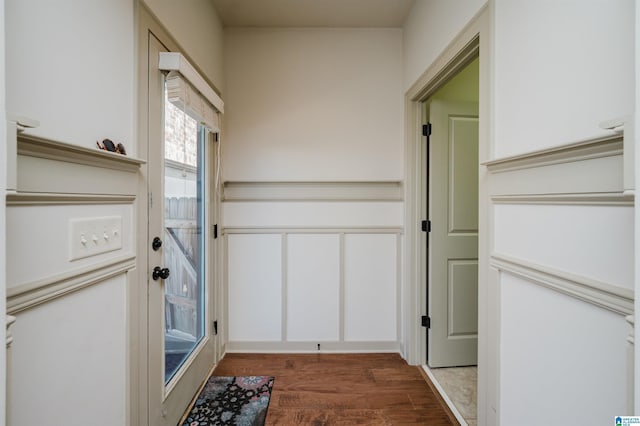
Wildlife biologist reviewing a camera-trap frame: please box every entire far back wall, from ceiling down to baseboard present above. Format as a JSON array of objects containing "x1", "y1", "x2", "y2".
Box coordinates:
[{"x1": 222, "y1": 28, "x2": 403, "y2": 351}]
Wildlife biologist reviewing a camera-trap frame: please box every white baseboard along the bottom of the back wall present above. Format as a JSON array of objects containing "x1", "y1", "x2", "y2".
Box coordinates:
[{"x1": 226, "y1": 341, "x2": 400, "y2": 353}]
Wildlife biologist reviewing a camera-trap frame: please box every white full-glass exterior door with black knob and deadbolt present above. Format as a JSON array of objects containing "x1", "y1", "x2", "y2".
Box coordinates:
[{"x1": 147, "y1": 36, "x2": 216, "y2": 426}]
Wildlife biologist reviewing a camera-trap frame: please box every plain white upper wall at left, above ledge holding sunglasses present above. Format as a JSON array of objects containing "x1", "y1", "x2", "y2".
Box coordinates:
[{"x1": 5, "y1": 0, "x2": 135, "y2": 153}]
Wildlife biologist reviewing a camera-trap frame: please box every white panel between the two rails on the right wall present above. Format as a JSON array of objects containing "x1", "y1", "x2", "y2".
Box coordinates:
[{"x1": 494, "y1": 204, "x2": 634, "y2": 289}]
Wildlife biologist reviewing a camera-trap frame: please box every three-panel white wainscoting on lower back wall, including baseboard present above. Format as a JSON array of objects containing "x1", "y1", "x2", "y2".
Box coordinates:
[{"x1": 225, "y1": 228, "x2": 400, "y2": 352}]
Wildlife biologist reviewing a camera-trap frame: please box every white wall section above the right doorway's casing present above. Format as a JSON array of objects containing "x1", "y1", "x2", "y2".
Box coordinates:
[{"x1": 402, "y1": 0, "x2": 486, "y2": 90}]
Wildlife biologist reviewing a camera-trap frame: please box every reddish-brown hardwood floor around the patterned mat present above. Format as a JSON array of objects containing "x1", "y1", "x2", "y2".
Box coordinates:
[{"x1": 213, "y1": 354, "x2": 458, "y2": 426}]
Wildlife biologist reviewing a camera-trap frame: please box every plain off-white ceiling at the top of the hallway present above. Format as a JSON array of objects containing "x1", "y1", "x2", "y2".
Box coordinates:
[{"x1": 212, "y1": 0, "x2": 415, "y2": 27}]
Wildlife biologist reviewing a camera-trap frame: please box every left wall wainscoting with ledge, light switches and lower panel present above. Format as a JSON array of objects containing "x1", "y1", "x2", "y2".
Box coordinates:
[{"x1": 6, "y1": 134, "x2": 142, "y2": 425}]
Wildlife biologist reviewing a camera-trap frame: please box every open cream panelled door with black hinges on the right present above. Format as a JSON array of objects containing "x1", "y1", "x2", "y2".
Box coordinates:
[{"x1": 427, "y1": 99, "x2": 478, "y2": 367}]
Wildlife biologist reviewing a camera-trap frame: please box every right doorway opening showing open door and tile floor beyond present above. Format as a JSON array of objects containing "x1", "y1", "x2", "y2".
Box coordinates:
[{"x1": 421, "y1": 52, "x2": 480, "y2": 424}]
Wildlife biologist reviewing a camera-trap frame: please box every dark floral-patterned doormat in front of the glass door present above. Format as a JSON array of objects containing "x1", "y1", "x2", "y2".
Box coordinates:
[{"x1": 182, "y1": 376, "x2": 274, "y2": 426}]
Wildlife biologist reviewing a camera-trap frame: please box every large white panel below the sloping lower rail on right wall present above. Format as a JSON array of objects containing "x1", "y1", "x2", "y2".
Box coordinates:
[{"x1": 500, "y1": 272, "x2": 633, "y2": 425}]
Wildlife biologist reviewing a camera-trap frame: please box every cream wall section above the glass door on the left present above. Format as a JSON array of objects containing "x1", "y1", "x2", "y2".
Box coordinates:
[{"x1": 143, "y1": 0, "x2": 224, "y2": 92}]
